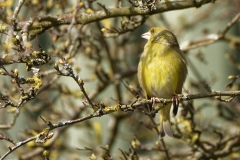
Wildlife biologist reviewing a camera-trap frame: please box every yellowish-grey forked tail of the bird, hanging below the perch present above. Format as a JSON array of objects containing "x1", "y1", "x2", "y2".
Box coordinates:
[{"x1": 159, "y1": 103, "x2": 173, "y2": 139}]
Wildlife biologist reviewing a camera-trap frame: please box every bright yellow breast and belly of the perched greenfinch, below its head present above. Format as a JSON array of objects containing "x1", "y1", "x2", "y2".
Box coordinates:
[{"x1": 138, "y1": 51, "x2": 183, "y2": 98}]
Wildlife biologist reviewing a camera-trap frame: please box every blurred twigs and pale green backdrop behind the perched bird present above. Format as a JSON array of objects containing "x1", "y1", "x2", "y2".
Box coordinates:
[{"x1": 0, "y1": 0, "x2": 240, "y2": 160}]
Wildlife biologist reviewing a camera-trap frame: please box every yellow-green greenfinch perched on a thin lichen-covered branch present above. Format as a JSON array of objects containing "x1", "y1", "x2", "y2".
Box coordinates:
[{"x1": 138, "y1": 27, "x2": 187, "y2": 139}]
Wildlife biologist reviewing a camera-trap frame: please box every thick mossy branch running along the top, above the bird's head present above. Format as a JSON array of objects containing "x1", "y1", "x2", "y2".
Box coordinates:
[{"x1": 17, "y1": 0, "x2": 214, "y2": 30}]
